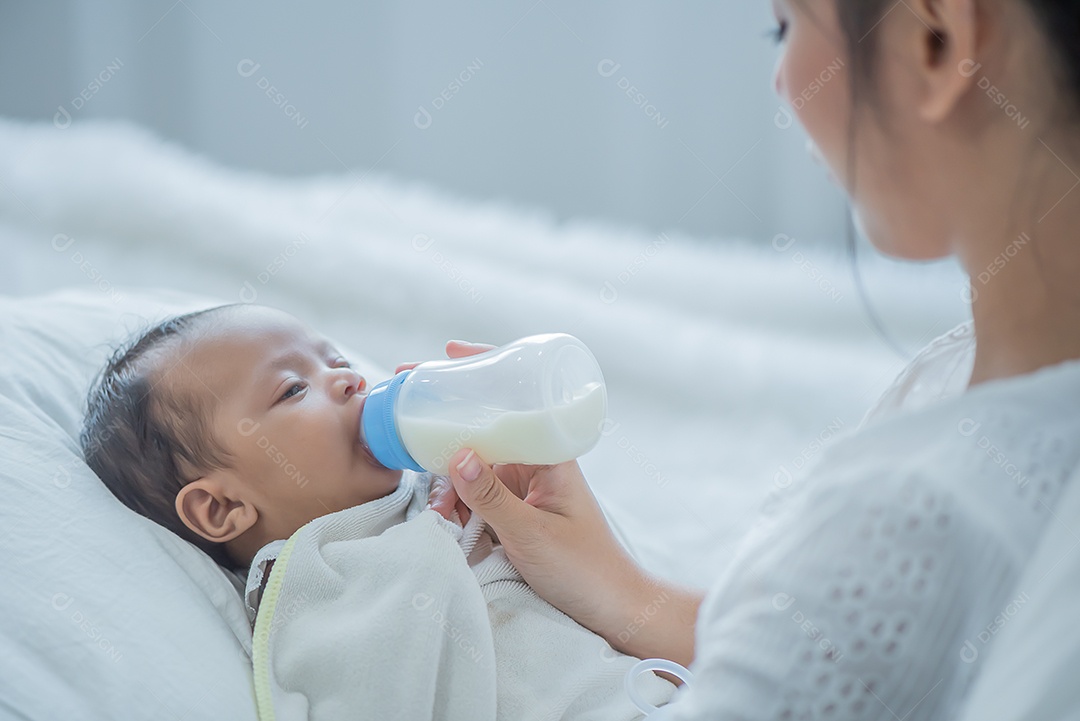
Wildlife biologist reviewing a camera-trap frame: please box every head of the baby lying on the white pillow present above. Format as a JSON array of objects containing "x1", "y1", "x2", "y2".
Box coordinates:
[{"x1": 81, "y1": 305, "x2": 401, "y2": 569}]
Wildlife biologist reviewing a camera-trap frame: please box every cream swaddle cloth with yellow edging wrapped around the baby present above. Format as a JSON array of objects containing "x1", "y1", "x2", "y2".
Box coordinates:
[{"x1": 247, "y1": 472, "x2": 674, "y2": 721}]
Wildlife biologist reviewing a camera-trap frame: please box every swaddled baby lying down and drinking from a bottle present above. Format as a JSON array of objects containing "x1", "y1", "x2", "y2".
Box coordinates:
[{"x1": 81, "y1": 305, "x2": 674, "y2": 720}]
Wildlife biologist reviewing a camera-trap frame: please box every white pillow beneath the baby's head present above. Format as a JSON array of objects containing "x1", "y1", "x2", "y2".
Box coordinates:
[{"x1": 0, "y1": 290, "x2": 387, "y2": 721}]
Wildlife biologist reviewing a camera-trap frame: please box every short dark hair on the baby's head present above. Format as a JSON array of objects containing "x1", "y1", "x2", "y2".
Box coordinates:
[{"x1": 79, "y1": 305, "x2": 238, "y2": 570}]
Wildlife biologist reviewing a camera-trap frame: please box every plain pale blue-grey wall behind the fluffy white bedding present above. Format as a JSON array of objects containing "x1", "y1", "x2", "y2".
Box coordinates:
[{"x1": 0, "y1": 0, "x2": 845, "y2": 243}]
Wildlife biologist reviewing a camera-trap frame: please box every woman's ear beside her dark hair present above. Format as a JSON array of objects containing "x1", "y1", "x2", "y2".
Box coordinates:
[{"x1": 911, "y1": 0, "x2": 980, "y2": 123}]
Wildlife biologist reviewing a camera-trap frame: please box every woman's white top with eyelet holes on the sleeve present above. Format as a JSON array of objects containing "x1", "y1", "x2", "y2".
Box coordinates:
[{"x1": 660, "y1": 323, "x2": 1080, "y2": 721}]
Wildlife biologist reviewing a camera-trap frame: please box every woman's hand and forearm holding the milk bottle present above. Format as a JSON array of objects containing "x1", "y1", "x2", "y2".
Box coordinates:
[{"x1": 400, "y1": 341, "x2": 702, "y2": 665}]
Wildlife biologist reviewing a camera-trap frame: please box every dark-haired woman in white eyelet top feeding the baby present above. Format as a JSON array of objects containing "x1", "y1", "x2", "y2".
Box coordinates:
[{"x1": 419, "y1": 0, "x2": 1080, "y2": 719}]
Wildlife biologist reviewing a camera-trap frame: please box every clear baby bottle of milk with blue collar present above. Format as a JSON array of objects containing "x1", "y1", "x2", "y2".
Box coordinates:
[{"x1": 360, "y1": 334, "x2": 607, "y2": 474}]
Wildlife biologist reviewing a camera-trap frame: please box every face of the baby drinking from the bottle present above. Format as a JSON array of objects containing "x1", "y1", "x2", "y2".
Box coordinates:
[{"x1": 164, "y1": 305, "x2": 402, "y2": 540}]
